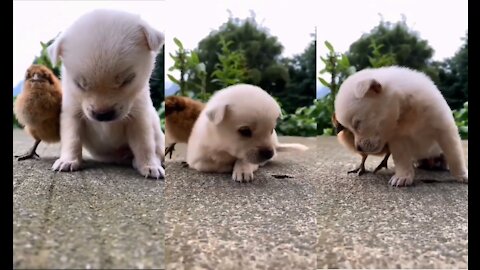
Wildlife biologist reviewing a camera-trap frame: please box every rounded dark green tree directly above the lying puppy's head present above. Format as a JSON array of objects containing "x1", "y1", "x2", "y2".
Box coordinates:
[{"x1": 196, "y1": 16, "x2": 288, "y2": 94}]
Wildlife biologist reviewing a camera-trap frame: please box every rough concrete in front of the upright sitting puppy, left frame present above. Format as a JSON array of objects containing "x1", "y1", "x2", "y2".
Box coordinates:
[{"x1": 13, "y1": 130, "x2": 165, "y2": 269}]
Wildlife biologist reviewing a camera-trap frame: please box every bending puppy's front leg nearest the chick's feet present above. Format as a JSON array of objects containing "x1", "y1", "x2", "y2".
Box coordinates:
[{"x1": 388, "y1": 142, "x2": 415, "y2": 187}]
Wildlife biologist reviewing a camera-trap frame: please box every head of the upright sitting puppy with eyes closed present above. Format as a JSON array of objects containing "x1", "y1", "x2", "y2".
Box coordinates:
[{"x1": 48, "y1": 10, "x2": 164, "y2": 121}]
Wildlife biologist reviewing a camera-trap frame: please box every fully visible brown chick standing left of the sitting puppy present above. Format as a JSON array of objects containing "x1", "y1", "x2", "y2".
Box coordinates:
[{"x1": 13, "y1": 65, "x2": 62, "y2": 161}]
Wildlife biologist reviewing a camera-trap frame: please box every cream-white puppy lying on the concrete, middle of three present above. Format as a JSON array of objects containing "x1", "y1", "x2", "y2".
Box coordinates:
[{"x1": 187, "y1": 84, "x2": 308, "y2": 182}]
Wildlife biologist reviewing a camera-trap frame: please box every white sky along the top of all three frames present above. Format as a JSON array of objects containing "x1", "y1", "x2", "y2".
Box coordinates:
[{"x1": 13, "y1": 0, "x2": 468, "y2": 85}]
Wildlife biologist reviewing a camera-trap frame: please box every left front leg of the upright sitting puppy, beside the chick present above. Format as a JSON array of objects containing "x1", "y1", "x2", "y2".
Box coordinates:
[{"x1": 52, "y1": 109, "x2": 83, "y2": 172}]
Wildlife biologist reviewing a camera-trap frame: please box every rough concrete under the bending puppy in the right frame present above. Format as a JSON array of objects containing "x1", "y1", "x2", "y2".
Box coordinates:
[{"x1": 315, "y1": 137, "x2": 468, "y2": 269}]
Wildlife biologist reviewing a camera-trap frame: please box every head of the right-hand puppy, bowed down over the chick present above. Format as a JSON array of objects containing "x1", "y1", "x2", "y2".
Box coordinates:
[{"x1": 335, "y1": 70, "x2": 400, "y2": 154}]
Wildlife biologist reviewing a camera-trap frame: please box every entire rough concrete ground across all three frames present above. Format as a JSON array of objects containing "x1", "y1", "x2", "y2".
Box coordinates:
[{"x1": 13, "y1": 130, "x2": 468, "y2": 269}]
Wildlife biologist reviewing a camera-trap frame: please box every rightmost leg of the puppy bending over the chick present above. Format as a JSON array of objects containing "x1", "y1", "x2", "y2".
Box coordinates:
[{"x1": 437, "y1": 127, "x2": 468, "y2": 183}]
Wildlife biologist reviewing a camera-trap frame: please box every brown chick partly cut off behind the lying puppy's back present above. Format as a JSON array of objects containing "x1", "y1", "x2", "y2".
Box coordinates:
[{"x1": 165, "y1": 96, "x2": 205, "y2": 158}]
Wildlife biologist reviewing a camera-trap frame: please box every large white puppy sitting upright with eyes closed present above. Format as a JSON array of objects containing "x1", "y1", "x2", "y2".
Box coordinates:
[{"x1": 48, "y1": 10, "x2": 165, "y2": 179}]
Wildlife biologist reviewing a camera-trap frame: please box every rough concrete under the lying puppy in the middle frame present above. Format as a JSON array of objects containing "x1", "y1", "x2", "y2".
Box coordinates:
[{"x1": 165, "y1": 137, "x2": 317, "y2": 269}]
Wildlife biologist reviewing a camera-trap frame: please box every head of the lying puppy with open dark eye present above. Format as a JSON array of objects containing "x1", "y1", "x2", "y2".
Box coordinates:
[{"x1": 204, "y1": 84, "x2": 281, "y2": 164}]
